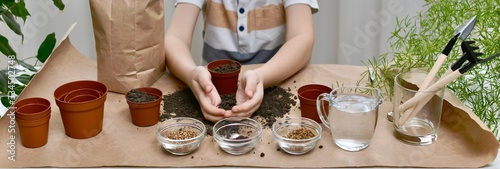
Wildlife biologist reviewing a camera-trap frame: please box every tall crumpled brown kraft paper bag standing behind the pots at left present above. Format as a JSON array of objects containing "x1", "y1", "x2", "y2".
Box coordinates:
[{"x1": 90, "y1": 0, "x2": 165, "y2": 94}]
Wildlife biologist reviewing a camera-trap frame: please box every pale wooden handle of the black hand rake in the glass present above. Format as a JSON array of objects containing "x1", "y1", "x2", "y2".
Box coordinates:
[{"x1": 395, "y1": 70, "x2": 462, "y2": 126}]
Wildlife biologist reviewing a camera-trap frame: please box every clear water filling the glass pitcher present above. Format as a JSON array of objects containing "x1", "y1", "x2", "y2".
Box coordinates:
[{"x1": 328, "y1": 94, "x2": 379, "y2": 151}]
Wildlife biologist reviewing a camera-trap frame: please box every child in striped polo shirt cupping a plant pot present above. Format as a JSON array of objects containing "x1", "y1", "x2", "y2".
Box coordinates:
[{"x1": 165, "y1": 0, "x2": 318, "y2": 122}]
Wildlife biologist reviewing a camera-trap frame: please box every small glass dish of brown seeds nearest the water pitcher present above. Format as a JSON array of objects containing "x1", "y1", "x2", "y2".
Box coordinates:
[{"x1": 272, "y1": 117, "x2": 322, "y2": 155}]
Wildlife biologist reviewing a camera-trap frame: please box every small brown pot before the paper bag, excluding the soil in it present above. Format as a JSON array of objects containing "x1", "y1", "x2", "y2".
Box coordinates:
[{"x1": 125, "y1": 87, "x2": 163, "y2": 127}]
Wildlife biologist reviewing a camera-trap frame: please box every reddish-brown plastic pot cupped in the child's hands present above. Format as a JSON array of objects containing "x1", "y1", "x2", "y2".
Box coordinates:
[{"x1": 207, "y1": 59, "x2": 241, "y2": 94}]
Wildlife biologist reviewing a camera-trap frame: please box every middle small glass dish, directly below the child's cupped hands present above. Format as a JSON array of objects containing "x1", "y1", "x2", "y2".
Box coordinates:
[{"x1": 213, "y1": 117, "x2": 262, "y2": 155}]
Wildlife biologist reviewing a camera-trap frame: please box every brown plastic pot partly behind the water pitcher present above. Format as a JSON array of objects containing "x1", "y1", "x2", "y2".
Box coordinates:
[{"x1": 297, "y1": 84, "x2": 332, "y2": 123}]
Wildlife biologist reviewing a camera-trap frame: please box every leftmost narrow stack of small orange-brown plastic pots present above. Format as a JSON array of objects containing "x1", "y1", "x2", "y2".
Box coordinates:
[{"x1": 14, "y1": 97, "x2": 51, "y2": 148}]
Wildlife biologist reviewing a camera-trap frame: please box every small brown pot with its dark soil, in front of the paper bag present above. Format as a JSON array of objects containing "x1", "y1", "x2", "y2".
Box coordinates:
[{"x1": 125, "y1": 87, "x2": 163, "y2": 127}]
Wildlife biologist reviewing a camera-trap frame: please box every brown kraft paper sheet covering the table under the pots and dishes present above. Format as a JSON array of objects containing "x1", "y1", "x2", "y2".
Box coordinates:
[{"x1": 0, "y1": 36, "x2": 499, "y2": 168}]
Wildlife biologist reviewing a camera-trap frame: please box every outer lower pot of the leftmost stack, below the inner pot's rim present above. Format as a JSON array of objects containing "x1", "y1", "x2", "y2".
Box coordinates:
[{"x1": 16, "y1": 114, "x2": 50, "y2": 148}]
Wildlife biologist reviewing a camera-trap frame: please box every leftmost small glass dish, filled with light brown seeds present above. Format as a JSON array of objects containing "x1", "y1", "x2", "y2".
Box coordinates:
[{"x1": 156, "y1": 117, "x2": 206, "y2": 155}]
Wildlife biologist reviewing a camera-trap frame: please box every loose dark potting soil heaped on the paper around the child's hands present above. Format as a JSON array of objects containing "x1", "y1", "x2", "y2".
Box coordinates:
[{"x1": 160, "y1": 87, "x2": 297, "y2": 135}]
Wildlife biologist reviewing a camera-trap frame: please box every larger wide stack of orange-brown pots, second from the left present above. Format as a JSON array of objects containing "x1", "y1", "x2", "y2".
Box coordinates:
[{"x1": 54, "y1": 80, "x2": 108, "y2": 139}]
